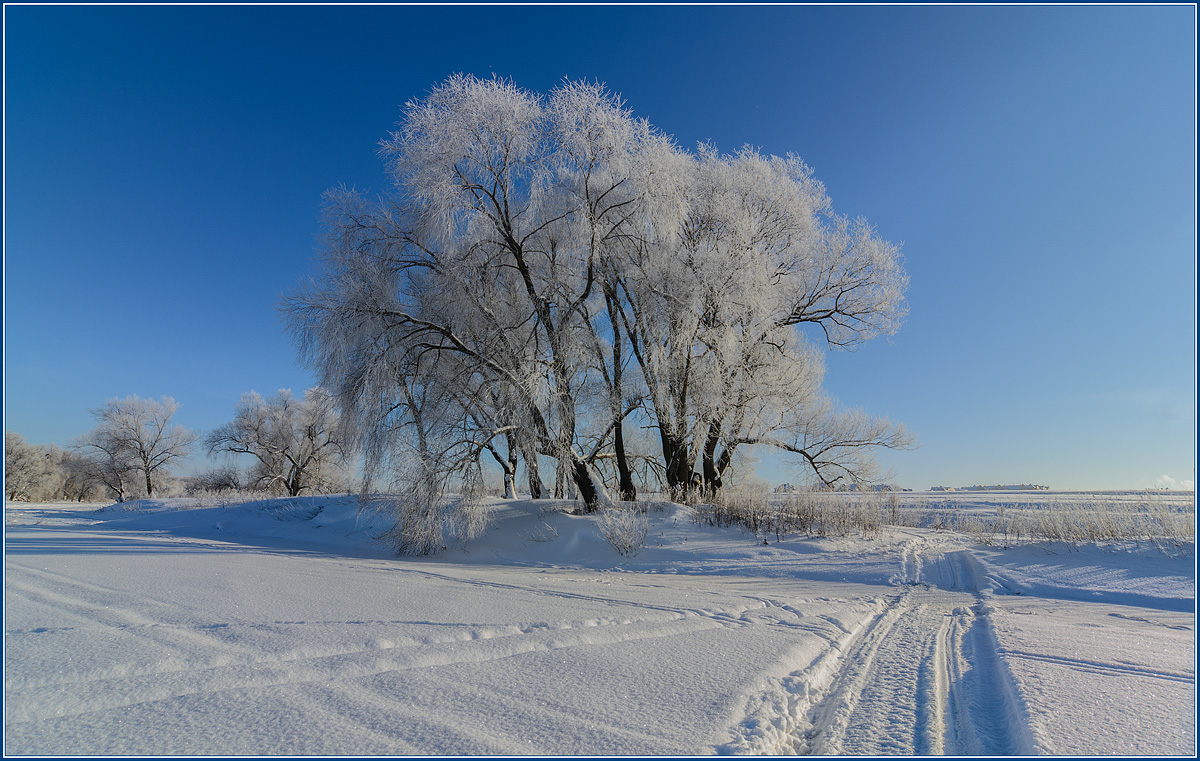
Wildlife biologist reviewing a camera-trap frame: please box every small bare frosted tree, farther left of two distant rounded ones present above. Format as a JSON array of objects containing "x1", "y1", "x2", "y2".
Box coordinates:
[{"x1": 76, "y1": 396, "x2": 198, "y2": 499}]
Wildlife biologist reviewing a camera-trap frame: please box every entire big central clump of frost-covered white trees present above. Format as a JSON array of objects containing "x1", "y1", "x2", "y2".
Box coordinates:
[{"x1": 283, "y1": 76, "x2": 908, "y2": 532}]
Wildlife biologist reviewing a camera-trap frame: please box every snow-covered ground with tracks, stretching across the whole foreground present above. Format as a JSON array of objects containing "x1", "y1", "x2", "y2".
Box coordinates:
[{"x1": 4, "y1": 493, "x2": 1196, "y2": 755}]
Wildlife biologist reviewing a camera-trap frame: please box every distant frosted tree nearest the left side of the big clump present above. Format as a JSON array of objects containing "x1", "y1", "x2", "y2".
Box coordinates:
[{"x1": 204, "y1": 387, "x2": 350, "y2": 497}]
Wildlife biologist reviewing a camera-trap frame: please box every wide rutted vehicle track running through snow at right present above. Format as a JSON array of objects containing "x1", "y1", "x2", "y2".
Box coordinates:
[{"x1": 716, "y1": 538, "x2": 1041, "y2": 756}]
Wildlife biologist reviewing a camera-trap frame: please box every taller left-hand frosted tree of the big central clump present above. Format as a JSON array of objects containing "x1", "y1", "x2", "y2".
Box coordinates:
[{"x1": 278, "y1": 77, "x2": 670, "y2": 507}]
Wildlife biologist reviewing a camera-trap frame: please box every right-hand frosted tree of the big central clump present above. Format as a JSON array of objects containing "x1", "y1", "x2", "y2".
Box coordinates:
[{"x1": 622, "y1": 146, "x2": 910, "y2": 491}]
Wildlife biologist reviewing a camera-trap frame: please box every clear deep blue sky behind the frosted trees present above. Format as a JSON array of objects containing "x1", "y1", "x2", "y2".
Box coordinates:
[{"x1": 4, "y1": 6, "x2": 1196, "y2": 489}]
